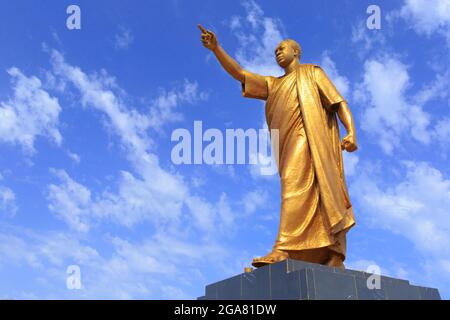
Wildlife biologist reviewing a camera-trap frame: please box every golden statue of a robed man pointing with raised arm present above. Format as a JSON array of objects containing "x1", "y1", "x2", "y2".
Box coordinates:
[{"x1": 198, "y1": 25, "x2": 357, "y2": 268}]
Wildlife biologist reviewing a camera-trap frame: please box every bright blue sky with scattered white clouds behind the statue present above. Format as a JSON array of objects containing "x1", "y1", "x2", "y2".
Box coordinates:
[{"x1": 0, "y1": 0, "x2": 450, "y2": 299}]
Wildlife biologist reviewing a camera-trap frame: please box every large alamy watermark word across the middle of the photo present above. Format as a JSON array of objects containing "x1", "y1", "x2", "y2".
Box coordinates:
[{"x1": 171, "y1": 121, "x2": 279, "y2": 175}]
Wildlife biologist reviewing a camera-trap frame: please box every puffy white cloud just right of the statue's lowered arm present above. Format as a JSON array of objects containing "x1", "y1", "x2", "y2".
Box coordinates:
[{"x1": 354, "y1": 57, "x2": 431, "y2": 154}]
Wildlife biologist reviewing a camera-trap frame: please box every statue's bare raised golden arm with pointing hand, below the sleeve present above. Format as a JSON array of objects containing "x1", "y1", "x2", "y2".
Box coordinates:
[{"x1": 198, "y1": 25, "x2": 245, "y2": 83}]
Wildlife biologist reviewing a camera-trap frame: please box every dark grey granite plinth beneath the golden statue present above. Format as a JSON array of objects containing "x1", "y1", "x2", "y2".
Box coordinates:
[{"x1": 199, "y1": 259, "x2": 441, "y2": 300}]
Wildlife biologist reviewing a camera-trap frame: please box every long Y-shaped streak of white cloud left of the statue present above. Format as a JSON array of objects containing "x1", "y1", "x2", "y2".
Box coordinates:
[{"x1": 46, "y1": 50, "x2": 204, "y2": 230}]
